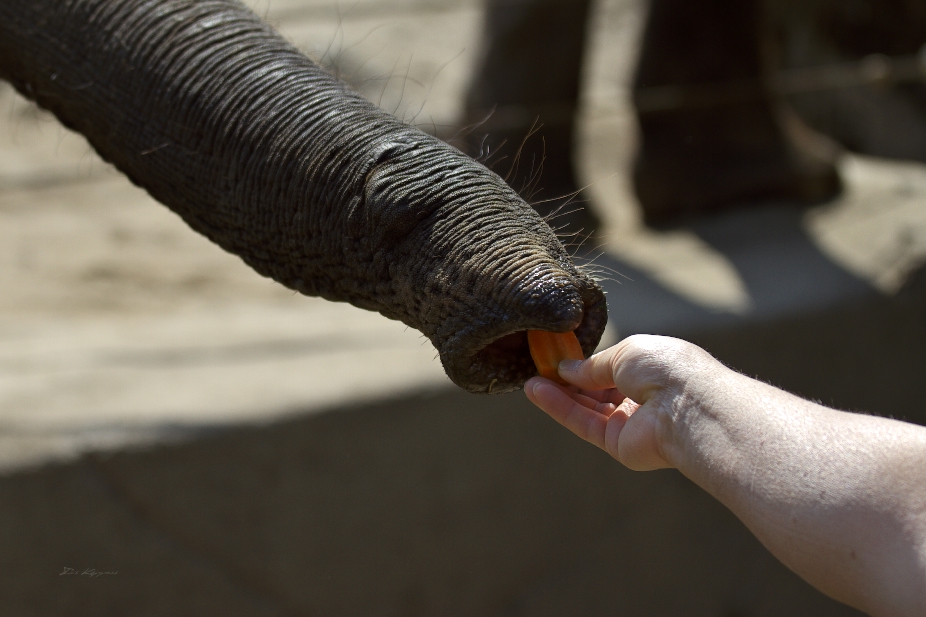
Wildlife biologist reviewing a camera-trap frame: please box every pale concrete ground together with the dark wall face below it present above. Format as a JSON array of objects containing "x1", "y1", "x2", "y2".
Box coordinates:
[{"x1": 0, "y1": 0, "x2": 926, "y2": 615}]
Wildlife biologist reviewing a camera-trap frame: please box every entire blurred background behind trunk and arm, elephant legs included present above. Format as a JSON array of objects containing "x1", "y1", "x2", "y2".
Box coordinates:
[{"x1": 0, "y1": 0, "x2": 926, "y2": 616}]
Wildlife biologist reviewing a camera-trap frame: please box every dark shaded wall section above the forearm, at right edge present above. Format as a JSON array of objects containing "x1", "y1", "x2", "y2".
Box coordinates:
[{"x1": 686, "y1": 274, "x2": 926, "y2": 425}]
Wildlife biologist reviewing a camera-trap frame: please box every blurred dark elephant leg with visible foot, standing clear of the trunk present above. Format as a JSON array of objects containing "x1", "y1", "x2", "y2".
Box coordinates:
[{"x1": 634, "y1": 0, "x2": 840, "y2": 224}]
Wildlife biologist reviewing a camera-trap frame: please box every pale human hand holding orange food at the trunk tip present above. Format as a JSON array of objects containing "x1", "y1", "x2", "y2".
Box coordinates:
[{"x1": 524, "y1": 335, "x2": 707, "y2": 471}]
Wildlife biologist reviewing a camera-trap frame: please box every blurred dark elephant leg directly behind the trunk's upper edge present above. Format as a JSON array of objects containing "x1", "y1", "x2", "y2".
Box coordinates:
[{"x1": 465, "y1": 0, "x2": 598, "y2": 235}]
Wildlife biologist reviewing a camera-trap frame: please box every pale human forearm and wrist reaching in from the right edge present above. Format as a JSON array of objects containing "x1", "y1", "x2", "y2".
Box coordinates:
[{"x1": 663, "y1": 363, "x2": 926, "y2": 615}]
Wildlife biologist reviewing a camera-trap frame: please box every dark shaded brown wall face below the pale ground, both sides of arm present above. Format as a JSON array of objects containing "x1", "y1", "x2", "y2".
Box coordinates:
[{"x1": 0, "y1": 280, "x2": 926, "y2": 616}]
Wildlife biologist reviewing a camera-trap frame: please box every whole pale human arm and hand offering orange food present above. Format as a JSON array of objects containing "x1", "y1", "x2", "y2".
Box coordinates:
[{"x1": 524, "y1": 335, "x2": 926, "y2": 616}]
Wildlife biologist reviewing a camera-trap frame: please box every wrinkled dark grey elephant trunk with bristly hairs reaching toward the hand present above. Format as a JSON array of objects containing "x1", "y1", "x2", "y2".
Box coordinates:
[{"x1": 0, "y1": 0, "x2": 607, "y2": 392}]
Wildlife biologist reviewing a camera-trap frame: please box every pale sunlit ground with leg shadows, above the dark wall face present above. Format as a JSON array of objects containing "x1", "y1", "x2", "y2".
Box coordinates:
[{"x1": 0, "y1": 0, "x2": 926, "y2": 469}]
